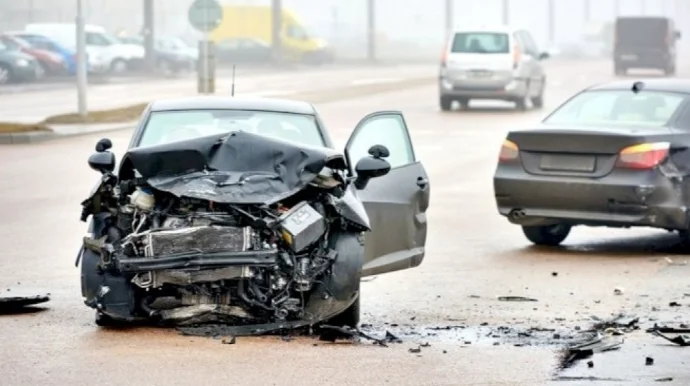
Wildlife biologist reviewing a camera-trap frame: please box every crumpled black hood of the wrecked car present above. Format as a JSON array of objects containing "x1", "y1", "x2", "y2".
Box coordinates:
[{"x1": 120, "y1": 131, "x2": 346, "y2": 205}]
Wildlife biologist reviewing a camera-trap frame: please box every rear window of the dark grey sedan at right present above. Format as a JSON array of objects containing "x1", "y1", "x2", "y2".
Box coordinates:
[{"x1": 544, "y1": 90, "x2": 686, "y2": 127}]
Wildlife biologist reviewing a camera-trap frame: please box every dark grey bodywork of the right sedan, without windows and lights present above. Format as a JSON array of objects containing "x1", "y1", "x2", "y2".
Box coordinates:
[{"x1": 494, "y1": 79, "x2": 690, "y2": 230}]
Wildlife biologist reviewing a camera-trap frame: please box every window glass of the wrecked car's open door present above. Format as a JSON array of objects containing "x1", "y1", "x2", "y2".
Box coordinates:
[{"x1": 348, "y1": 114, "x2": 415, "y2": 168}]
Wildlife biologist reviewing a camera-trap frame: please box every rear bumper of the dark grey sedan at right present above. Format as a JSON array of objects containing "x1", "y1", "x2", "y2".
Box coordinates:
[{"x1": 494, "y1": 166, "x2": 688, "y2": 230}]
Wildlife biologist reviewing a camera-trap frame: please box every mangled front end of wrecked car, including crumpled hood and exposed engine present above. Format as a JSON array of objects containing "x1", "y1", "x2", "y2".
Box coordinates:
[{"x1": 78, "y1": 132, "x2": 369, "y2": 328}]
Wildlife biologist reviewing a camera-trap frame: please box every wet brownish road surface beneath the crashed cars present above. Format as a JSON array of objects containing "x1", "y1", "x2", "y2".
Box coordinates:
[{"x1": 0, "y1": 58, "x2": 690, "y2": 386}]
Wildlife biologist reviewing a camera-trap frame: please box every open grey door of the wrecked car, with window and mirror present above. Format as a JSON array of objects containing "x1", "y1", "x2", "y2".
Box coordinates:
[{"x1": 345, "y1": 111, "x2": 430, "y2": 276}]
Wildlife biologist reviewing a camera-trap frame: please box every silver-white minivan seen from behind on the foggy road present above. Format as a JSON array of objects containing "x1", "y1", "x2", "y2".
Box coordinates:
[{"x1": 439, "y1": 26, "x2": 549, "y2": 111}]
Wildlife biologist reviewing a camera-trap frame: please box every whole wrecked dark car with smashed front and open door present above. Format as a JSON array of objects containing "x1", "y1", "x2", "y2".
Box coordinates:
[{"x1": 77, "y1": 97, "x2": 429, "y2": 328}]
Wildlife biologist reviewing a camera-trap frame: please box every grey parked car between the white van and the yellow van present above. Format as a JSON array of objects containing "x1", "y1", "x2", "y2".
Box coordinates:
[{"x1": 119, "y1": 36, "x2": 199, "y2": 75}]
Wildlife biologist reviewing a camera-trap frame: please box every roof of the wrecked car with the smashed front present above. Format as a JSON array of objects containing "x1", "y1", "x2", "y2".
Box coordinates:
[{"x1": 150, "y1": 96, "x2": 316, "y2": 115}]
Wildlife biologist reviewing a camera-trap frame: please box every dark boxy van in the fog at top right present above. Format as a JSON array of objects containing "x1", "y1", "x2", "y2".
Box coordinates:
[{"x1": 613, "y1": 17, "x2": 680, "y2": 75}]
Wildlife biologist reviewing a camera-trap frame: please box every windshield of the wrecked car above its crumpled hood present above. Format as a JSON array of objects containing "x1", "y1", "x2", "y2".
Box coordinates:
[{"x1": 138, "y1": 110, "x2": 326, "y2": 147}]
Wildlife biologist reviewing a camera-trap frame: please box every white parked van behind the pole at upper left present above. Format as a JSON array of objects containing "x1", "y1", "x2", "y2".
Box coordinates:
[{"x1": 24, "y1": 23, "x2": 144, "y2": 74}]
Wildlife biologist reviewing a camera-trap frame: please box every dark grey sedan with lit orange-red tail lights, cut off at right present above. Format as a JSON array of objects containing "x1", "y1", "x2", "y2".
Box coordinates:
[{"x1": 494, "y1": 79, "x2": 690, "y2": 245}]
